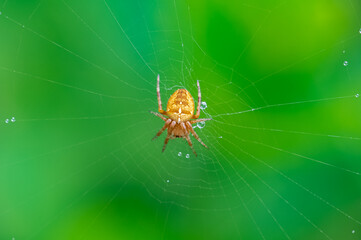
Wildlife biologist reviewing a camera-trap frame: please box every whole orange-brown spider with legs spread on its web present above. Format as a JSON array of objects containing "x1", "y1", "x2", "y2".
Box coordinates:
[{"x1": 151, "y1": 75, "x2": 212, "y2": 156}]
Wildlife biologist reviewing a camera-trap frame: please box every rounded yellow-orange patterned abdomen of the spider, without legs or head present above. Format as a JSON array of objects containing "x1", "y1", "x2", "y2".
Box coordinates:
[{"x1": 167, "y1": 89, "x2": 194, "y2": 123}]
